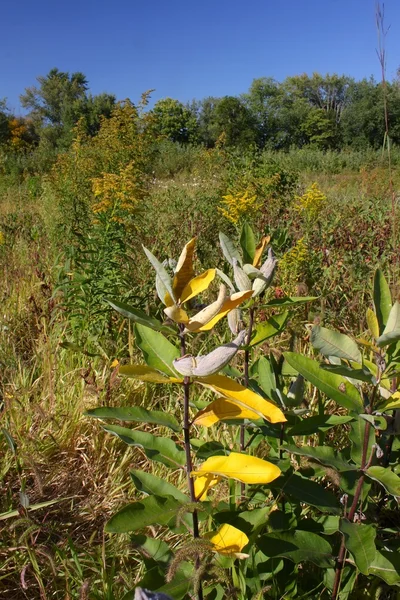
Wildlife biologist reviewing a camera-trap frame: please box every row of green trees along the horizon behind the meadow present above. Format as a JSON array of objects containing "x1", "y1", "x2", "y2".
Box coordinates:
[{"x1": 0, "y1": 69, "x2": 400, "y2": 159}]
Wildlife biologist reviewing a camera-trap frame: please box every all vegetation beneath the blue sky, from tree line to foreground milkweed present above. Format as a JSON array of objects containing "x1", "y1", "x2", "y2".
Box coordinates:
[{"x1": 0, "y1": 69, "x2": 400, "y2": 600}]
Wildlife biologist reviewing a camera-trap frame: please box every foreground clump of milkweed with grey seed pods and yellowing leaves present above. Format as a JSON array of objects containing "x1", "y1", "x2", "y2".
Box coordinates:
[{"x1": 87, "y1": 223, "x2": 400, "y2": 600}]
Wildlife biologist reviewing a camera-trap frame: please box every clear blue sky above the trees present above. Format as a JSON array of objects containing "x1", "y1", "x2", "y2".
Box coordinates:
[{"x1": 0, "y1": 0, "x2": 400, "y2": 113}]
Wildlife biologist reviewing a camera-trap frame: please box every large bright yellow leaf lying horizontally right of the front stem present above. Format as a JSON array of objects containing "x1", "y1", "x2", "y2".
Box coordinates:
[{"x1": 191, "y1": 452, "x2": 281, "y2": 483}]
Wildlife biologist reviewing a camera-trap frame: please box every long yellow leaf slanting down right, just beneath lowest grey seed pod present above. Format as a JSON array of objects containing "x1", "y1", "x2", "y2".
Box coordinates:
[{"x1": 196, "y1": 375, "x2": 286, "y2": 423}]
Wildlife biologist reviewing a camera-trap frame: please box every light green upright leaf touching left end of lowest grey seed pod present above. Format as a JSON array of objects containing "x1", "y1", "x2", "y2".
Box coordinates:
[{"x1": 135, "y1": 323, "x2": 180, "y2": 378}]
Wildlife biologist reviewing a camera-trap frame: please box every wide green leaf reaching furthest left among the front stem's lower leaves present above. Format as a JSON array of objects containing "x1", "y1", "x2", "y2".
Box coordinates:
[{"x1": 104, "y1": 496, "x2": 182, "y2": 533}]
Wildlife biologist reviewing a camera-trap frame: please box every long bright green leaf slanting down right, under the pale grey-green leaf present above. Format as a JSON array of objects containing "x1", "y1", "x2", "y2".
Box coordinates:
[{"x1": 284, "y1": 352, "x2": 364, "y2": 413}]
